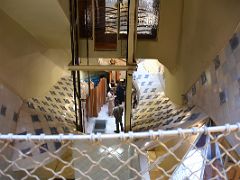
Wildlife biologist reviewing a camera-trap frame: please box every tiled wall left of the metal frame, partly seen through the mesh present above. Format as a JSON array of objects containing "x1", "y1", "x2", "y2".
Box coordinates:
[{"x1": 0, "y1": 76, "x2": 76, "y2": 171}]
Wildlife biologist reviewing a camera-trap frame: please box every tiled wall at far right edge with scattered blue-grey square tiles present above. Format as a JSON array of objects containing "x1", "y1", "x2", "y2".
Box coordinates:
[{"x1": 187, "y1": 33, "x2": 240, "y2": 125}]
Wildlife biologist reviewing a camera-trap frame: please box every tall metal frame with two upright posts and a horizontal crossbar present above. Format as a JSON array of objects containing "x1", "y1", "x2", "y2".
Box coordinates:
[{"x1": 68, "y1": 0, "x2": 138, "y2": 132}]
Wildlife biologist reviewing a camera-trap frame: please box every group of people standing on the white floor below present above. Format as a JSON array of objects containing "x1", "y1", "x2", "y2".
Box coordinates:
[{"x1": 107, "y1": 82, "x2": 125, "y2": 133}]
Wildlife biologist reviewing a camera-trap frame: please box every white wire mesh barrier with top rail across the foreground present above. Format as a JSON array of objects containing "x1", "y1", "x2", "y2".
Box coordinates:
[{"x1": 0, "y1": 124, "x2": 240, "y2": 180}]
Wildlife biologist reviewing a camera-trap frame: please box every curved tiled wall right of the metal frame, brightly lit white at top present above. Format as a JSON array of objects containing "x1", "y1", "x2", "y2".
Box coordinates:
[{"x1": 132, "y1": 63, "x2": 208, "y2": 131}]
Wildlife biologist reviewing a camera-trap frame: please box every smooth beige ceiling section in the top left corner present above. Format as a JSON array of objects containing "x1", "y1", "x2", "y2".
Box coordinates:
[{"x1": 0, "y1": 0, "x2": 70, "y2": 49}]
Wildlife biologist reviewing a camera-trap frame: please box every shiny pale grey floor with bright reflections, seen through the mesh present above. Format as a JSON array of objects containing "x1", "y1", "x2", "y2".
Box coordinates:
[{"x1": 73, "y1": 139, "x2": 138, "y2": 180}]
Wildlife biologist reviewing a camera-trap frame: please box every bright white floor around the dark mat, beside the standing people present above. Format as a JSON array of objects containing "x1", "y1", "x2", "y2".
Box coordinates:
[{"x1": 86, "y1": 103, "x2": 124, "y2": 134}]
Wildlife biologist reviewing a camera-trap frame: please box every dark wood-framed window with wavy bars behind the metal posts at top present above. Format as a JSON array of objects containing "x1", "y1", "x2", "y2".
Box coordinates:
[{"x1": 79, "y1": 0, "x2": 160, "y2": 39}]
